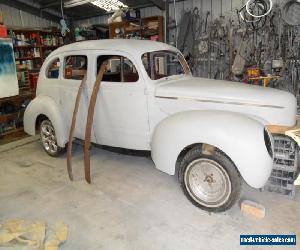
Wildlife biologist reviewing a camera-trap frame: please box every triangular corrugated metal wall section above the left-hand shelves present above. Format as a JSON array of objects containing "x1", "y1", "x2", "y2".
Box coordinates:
[{"x1": 0, "y1": 4, "x2": 58, "y2": 28}]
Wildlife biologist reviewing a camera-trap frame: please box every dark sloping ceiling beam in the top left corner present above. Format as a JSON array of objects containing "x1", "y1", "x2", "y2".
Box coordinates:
[{"x1": 0, "y1": 0, "x2": 61, "y2": 23}]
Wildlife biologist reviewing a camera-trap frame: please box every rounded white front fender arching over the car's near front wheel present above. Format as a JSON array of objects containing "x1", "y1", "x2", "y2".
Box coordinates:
[{"x1": 151, "y1": 111, "x2": 273, "y2": 188}]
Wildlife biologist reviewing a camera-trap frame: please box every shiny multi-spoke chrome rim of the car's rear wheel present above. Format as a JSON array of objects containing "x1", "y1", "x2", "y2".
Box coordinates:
[{"x1": 41, "y1": 123, "x2": 58, "y2": 154}]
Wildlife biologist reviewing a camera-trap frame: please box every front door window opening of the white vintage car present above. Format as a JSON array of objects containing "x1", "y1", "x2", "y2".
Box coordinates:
[{"x1": 97, "y1": 55, "x2": 139, "y2": 82}]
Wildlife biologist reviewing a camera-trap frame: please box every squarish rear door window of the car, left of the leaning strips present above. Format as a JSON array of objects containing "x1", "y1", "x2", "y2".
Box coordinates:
[{"x1": 64, "y1": 55, "x2": 88, "y2": 80}]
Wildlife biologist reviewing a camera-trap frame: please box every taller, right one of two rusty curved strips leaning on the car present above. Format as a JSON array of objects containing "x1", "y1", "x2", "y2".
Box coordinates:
[{"x1": 84, "y1": 63, "x2": 106, "y2": 183}]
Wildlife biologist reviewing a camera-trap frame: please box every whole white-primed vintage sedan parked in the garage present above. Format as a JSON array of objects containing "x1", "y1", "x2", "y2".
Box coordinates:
[{"x1": 24, "y1": 39, "x2": 296, "y2": 212}]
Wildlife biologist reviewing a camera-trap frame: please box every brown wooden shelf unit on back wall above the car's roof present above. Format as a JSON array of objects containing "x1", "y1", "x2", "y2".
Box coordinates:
[{"x1": 109, "y1": 16, "x2": 164, "y2": 42}]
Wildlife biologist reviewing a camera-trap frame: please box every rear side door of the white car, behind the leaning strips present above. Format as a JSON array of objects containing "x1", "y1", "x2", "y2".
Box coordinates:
[{"x1": 60, "y1": 51, "x2": 95, "y2": 142}]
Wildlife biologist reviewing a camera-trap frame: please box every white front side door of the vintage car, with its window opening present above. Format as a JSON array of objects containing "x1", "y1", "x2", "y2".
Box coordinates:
[{"x1": 90, "y1": 51, "x2": 150, "y2": 150}]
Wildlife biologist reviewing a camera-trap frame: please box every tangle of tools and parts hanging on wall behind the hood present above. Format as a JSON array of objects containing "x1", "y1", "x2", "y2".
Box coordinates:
[{"x1": 174, "y1": 0, "x2": 300, "y2": 114}]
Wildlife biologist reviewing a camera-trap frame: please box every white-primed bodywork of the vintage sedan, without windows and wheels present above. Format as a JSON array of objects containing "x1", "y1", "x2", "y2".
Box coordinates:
[{"x1": 24, "y1": 40, "x2": 296, "y2": 188}]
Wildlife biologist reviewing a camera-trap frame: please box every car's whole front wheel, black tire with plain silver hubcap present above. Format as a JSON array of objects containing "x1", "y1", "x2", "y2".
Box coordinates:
[{"x1": 178, "y1": 146, "x2": 241, "y2": 212}]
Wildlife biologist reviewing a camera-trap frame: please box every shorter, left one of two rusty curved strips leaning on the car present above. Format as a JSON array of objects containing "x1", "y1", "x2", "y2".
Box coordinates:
[{"x1": 67, "y1": 74, "x2": 87, "y2": 181}]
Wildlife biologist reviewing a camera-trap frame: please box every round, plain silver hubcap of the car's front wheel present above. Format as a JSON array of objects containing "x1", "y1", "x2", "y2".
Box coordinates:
[{"x1": 184, "y1": 158, "x2": 231, "y2": 207}]
